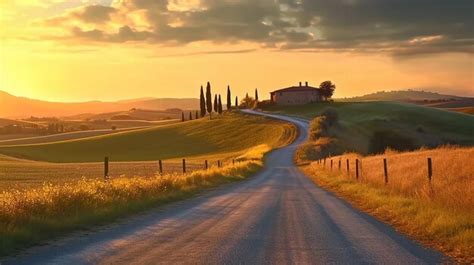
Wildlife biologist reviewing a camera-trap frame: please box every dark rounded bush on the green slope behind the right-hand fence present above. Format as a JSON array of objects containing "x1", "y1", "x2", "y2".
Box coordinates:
[{"x1": 369, "y1": 130, "x2": 418, "y2": 154}]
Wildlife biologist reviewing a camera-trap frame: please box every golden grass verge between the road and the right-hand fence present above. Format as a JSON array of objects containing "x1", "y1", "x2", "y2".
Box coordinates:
[{"x1": 301, "y1": 163, "x2": 474, "y2": 264}]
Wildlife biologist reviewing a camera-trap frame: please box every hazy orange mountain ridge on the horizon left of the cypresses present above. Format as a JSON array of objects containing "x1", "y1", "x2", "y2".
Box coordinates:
[{"x1": 0, "y1": 91, "x2": 199, "y2": 118}]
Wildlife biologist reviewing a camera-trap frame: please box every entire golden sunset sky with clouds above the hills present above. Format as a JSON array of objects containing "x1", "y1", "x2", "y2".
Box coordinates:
[{"x1": 0, "y1": 0, "x2": 474, "y2": 101}]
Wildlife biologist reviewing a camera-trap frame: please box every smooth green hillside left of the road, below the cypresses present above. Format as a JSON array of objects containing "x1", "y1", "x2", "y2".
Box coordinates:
[{"x1": 0, "y1": 114, "x2": 293, "y2": 163}]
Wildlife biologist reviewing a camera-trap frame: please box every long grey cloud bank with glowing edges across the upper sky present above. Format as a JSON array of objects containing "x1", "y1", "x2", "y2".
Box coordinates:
[{"x1": 38, "y1": 0, "x2": 474, "y2": 56}]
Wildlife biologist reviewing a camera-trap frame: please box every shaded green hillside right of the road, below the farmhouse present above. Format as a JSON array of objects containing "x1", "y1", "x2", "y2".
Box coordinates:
[{"x1": 267, "y1": 102, "x2": 474, "y2": 154}]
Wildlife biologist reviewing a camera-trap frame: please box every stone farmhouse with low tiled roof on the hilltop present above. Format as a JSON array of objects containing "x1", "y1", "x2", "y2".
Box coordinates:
[{"x1": 270, "y1": 82, "x2": 322, "y2": 105}]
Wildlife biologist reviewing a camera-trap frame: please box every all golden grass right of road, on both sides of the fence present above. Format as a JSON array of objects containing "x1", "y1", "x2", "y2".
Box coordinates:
[{"x1": 302, "y1": 147, "x2": 474, "y2": 263}]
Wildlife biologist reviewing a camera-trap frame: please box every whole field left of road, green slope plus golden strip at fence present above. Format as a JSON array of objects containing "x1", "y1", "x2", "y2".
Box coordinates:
[{"x1": 0, "y1": 114, "x2": 295, "y2": 191}]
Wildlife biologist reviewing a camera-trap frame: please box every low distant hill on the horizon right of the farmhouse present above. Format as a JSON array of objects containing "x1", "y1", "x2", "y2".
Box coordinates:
[{"x1": 343, "y1": 89, "x2": 469, "y2": 101}]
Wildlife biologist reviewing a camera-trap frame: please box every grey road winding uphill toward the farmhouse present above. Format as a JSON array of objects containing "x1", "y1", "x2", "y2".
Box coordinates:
[{"x1": 1, "y1": 111, "x2": 446, "y2": 265}]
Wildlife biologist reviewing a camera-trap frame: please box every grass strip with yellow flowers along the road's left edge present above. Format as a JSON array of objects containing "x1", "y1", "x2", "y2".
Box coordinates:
[{"x1": 0, "y1": 145, "x2": 271, "y2": 256}]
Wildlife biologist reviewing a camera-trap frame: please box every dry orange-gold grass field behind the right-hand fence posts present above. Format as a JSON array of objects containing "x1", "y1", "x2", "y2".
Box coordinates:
[{"x1": 326, "y1": 146, "x2": 474, "y2": 212}]
